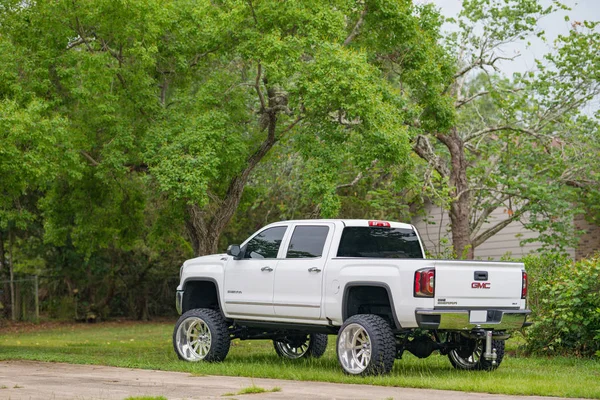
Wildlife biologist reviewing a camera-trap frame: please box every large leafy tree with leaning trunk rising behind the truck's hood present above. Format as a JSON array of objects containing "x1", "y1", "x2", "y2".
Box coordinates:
[{"x1": 146, "y1": 1, "x2": 448, "y2": 254}]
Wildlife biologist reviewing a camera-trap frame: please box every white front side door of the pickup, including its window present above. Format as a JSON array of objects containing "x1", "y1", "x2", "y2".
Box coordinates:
[{"x1": 224, "y1": 226, "x2": 288, "y2": 317}]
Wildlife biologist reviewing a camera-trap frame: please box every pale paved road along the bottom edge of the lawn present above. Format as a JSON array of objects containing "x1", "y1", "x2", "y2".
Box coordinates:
[{"x1": 0, "y1": 361, "x2": 584, "y2": 400}]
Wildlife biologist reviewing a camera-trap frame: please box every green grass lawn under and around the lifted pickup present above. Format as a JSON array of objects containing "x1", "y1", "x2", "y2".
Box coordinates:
[{"x1": 0, "y1": 321, "x2": 600, "y2": 399}]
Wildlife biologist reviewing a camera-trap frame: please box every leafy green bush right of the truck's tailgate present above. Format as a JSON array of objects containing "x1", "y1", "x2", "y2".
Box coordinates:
[{"x1": 525, "y1": 254, "x2": 600, "y2": 356}]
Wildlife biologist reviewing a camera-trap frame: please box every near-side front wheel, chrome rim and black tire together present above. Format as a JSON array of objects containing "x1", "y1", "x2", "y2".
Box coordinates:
[{"x1": 173, "y1": 308, "x2": 231, "y2": 362}]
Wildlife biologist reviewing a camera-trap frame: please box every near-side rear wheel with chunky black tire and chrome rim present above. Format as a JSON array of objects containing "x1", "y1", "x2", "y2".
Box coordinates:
[{"x1": 336, "y1": 314, "x2": 396, "y2": 375}]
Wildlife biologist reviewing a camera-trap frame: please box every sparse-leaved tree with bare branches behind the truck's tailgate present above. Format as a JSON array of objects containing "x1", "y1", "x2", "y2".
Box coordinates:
[{"x1": 413, "y1": 0, "x2": 600, "y2": 258}]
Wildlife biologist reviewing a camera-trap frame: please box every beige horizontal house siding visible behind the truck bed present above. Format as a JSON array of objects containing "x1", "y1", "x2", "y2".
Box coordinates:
[{"x1": 413, "y1": 204, "x2": 576, "y2": 260}]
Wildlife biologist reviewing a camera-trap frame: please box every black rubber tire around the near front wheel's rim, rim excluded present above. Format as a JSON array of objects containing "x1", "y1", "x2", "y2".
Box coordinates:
[{"x1": 173, "y1": 308, "x2": 231, "y2": 362}]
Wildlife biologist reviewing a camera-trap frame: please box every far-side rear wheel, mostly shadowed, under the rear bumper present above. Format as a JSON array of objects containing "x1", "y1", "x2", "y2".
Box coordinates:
[{"x1": 448, "y1": 338, "x2": 504, "y2": 371}]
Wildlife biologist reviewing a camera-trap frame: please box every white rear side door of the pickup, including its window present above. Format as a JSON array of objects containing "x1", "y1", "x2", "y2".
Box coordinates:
[{"x1": 273, "y1": 223, "x2": 335, "y2": 319}]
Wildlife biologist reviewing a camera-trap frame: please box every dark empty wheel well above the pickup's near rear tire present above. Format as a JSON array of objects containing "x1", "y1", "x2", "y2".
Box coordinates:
[{"x1": 343, "y1": 286, "x2": 400, "y2": 329}]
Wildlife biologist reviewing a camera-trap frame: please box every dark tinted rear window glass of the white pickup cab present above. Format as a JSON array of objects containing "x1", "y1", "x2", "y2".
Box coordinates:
[{"x1": 337, "y1": 226, "x2": 423, "y2": 258}]
